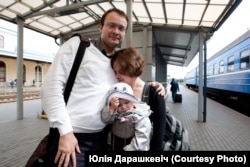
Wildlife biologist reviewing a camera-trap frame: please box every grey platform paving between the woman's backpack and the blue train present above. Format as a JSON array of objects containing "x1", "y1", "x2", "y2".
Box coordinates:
[{"x1": 166, "y1": 85, "x2": 250, "y2": 151}]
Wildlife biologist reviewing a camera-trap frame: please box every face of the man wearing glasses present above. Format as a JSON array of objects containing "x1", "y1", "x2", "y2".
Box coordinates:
[{"x1": 100, "y1": 12, "x2": 128, "y2": 53}]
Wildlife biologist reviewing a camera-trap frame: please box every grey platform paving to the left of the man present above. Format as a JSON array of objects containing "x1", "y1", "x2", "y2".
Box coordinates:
[{"x1": 0, "y1": 99, "x2": 49, "y2": 167}]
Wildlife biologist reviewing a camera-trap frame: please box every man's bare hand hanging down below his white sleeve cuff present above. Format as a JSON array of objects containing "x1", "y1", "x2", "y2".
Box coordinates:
[{"x1": 55, "y1": 132, "x2": 80, "y2": 167}]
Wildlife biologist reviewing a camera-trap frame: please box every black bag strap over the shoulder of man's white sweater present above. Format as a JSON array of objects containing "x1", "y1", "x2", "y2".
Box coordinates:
[{"x1": 64, "y1": 34, "x2": 90, "y2": 103}]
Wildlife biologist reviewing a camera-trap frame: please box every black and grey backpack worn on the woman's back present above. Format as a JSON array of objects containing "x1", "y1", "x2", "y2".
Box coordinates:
[{"x1": 142, "y1": 84, "x2": 190, "y2": 151}]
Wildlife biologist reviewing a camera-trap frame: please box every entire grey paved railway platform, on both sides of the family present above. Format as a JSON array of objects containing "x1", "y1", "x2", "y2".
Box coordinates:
[{"x1": 0, "y1": 85, "x2": 250, "y2": 167}]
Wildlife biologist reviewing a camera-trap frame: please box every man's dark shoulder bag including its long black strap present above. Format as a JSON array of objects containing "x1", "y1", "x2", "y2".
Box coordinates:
[{"x1": 25, "y1": 34, "x2": 90, "y2": 167}]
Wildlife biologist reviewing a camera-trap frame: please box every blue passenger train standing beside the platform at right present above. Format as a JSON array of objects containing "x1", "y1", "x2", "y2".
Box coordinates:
[{"x1": 184, "y1": 30, "x2": 250, "y2": 115}]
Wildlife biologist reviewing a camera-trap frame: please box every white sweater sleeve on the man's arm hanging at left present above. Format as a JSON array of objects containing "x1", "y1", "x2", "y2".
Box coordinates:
[{"x1": 41, "y1": 37, "x2": 80, "y2": 135}]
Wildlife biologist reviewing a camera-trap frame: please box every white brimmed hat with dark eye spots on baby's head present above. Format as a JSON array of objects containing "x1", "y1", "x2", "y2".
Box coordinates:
[{"x1": 107, "y1": 82, "x2": 140, "y2": 104}]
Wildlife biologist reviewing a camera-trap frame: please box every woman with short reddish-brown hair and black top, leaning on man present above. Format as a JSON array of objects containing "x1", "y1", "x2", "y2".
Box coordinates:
[{"x1": 111, "y1": 47, "x2": 166, "y2": 151}]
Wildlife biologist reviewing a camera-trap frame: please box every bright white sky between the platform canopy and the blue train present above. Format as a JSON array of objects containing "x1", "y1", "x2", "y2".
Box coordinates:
[{"x1": 168, "y1": 0, "x2": 250, "y2": 79}]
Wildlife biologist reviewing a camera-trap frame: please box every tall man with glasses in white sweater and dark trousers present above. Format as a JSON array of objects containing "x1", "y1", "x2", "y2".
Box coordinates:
[{"x1": 42, "y1": 9, "x2": 165, "y2": 167}]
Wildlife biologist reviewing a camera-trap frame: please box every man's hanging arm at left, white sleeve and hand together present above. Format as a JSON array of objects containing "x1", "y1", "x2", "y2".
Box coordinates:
[{"x1": 41, "y1": 37, "x2": 80, "y2": 167}]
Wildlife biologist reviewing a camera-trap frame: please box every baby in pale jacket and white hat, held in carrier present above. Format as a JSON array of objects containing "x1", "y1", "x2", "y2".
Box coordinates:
[{"x1": 102, "y1": 82, "x2": 151, "y2": 151}]
